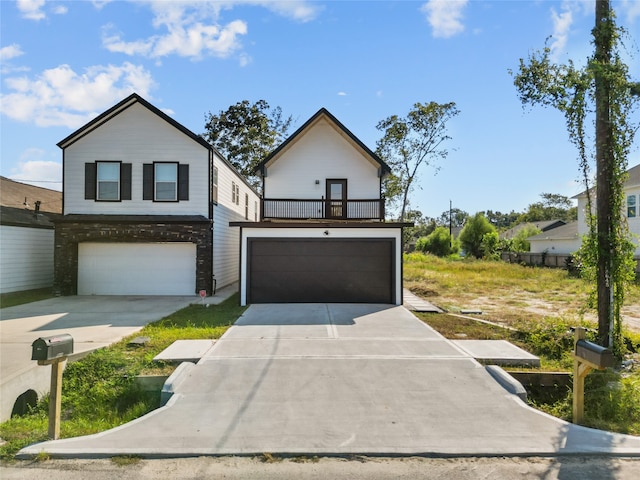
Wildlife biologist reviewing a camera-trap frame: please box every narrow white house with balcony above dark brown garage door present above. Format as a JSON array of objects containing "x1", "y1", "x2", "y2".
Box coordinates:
[{"x1": 233, "y1": 108, "x2": 405, "y2": 305}]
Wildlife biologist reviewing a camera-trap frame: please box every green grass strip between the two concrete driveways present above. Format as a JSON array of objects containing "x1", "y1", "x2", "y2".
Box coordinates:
[{"x1": 0, "y1": 295, "x2": 246, "y2": 460}]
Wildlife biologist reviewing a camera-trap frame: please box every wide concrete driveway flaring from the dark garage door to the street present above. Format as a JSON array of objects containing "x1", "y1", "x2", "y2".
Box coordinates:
[{"x1": 19, "y1": 304, "x2": 640, "y2": 458}]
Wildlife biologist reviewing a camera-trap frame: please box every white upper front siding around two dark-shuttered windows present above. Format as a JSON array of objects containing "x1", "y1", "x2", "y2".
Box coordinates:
[{"x1": 63, "y1": 103, "x2": 209, "y2": 216}]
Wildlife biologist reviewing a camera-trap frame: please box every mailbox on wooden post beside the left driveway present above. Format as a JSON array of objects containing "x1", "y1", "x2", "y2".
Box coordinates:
[{"x1": 31, "y1": 333, "x2": 73, "y2": 440}]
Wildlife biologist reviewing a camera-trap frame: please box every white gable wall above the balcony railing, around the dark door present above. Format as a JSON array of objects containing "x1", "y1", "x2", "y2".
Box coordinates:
[{"x1": 264, "y1": 119, "x2": 380, "y2": 199}]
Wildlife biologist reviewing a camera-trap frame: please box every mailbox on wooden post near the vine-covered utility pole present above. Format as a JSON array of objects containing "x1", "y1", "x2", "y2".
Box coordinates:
[{"x1": 573, "y1": 327, "x2": 615, "y2": 424}]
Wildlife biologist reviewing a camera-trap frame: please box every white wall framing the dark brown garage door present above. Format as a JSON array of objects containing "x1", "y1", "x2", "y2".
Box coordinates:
[{"x1": 240, "y1": 228, "x2": 402, "y2": 305}]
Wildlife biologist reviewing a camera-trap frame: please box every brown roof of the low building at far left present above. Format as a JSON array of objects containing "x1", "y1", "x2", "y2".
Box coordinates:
[{"x1": 0, "y1": 177, "x2": 62, "y2": 213}]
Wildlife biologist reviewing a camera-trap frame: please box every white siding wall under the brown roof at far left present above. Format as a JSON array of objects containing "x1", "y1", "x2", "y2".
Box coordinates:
[{"x1": 0, "y1": 225, "x2": 54, "y2": 293}]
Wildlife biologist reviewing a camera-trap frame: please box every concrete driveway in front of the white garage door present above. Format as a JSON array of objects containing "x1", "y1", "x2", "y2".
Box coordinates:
[{"x1": 0, "y1": 295, "x2": 198, "y2": 421}]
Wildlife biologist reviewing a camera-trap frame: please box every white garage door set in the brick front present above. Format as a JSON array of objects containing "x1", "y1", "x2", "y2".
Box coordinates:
[{"x1": 78, "y1": 242, "x2": 196, "y2": 295}]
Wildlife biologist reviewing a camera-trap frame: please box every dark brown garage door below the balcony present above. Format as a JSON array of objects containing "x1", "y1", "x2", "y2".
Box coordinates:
[{"x1": 247, "y1": 238, "x2": 395, "y2": 303}]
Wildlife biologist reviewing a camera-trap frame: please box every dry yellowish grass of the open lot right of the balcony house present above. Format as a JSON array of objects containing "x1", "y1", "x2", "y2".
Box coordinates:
[{"x1": 404, "y1": 253, "x2": 640, "y2": 324}]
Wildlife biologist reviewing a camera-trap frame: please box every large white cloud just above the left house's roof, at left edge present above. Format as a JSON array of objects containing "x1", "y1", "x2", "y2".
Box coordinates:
[{"x1": 0, "y1": 62, "x2": 154, "y2": 128}]
